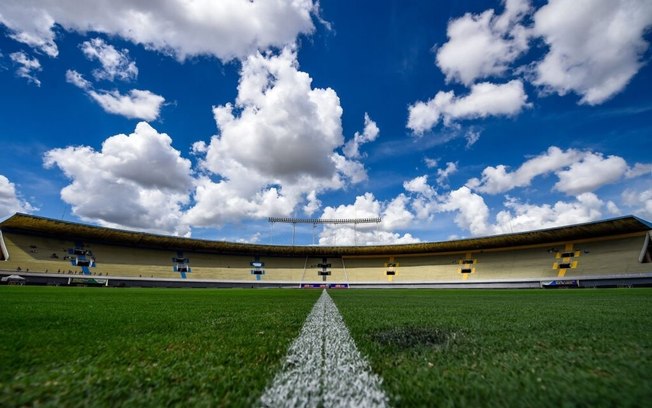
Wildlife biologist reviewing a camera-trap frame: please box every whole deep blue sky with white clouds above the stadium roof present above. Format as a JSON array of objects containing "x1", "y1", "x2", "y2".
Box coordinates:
[{"x1": 0, "y1": 0, "x2": 652, "y2": 245}]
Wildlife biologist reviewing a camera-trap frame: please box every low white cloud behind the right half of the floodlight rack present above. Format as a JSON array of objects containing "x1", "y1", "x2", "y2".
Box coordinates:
[{"x1": 319, "y1": 193, "x2": 419, "y2": 245}]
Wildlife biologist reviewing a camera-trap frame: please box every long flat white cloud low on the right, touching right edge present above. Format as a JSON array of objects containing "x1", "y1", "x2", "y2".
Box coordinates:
[{"x1": 467, "y1": 146, "x2": 650, "y2": 196}]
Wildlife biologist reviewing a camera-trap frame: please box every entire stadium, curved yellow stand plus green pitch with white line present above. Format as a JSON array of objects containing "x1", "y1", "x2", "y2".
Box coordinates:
[{"x1": 0, "y1": 214, "x2": 652, "y2": 407}]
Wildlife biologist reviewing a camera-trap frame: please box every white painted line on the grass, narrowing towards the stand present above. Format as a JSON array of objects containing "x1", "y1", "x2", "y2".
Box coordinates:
[{"x1": 260, "y1": 290, "x2": 388, "y2": 408}]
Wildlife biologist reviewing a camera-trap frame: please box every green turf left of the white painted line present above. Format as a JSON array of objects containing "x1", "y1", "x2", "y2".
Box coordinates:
[{"x1": 0, "y1": 286, "x2": 320, "y2": 407}]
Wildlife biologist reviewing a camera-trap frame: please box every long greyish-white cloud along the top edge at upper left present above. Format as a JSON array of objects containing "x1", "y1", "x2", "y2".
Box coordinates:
[{"x1": 0, "y1": 0, "x2": 317, "y2": 61}]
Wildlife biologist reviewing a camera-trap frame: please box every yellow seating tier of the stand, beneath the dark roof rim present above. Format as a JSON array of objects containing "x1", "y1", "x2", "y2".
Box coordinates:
[{"x1": 0, "y1": 232, "x2": 652, "y2": 283}]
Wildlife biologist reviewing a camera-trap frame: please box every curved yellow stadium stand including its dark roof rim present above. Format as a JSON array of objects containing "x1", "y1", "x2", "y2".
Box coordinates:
[{"x1": 0, "y1": 214, "x2": 652, "y2": 287}]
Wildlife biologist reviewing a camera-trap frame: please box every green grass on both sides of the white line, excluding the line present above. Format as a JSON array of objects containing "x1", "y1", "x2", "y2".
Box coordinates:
[{"x1": 0, "y1": 286, "x2": 652, "y2": 407}]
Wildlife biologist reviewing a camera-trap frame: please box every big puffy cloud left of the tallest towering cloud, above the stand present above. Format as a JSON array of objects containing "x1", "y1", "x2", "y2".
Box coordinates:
[{"x1": 44, "y1": 122, "x2": 193, "y2": 235}]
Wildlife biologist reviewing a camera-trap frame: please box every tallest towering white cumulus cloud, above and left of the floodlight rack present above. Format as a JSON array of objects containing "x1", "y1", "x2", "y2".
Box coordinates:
[{"x1": 187, "y1": 48, "x2": 366, "y2": 225}]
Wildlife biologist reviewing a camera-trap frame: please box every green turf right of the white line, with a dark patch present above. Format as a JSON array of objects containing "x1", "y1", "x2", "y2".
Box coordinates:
[{"x1": 331, "y1": 289, "x2": 652, "y2": 407}]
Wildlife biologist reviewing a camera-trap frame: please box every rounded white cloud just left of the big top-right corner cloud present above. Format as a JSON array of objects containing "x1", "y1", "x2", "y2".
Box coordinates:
[{"x1": 437, "y1": 0, "x2": 530, "y2": 86}]
